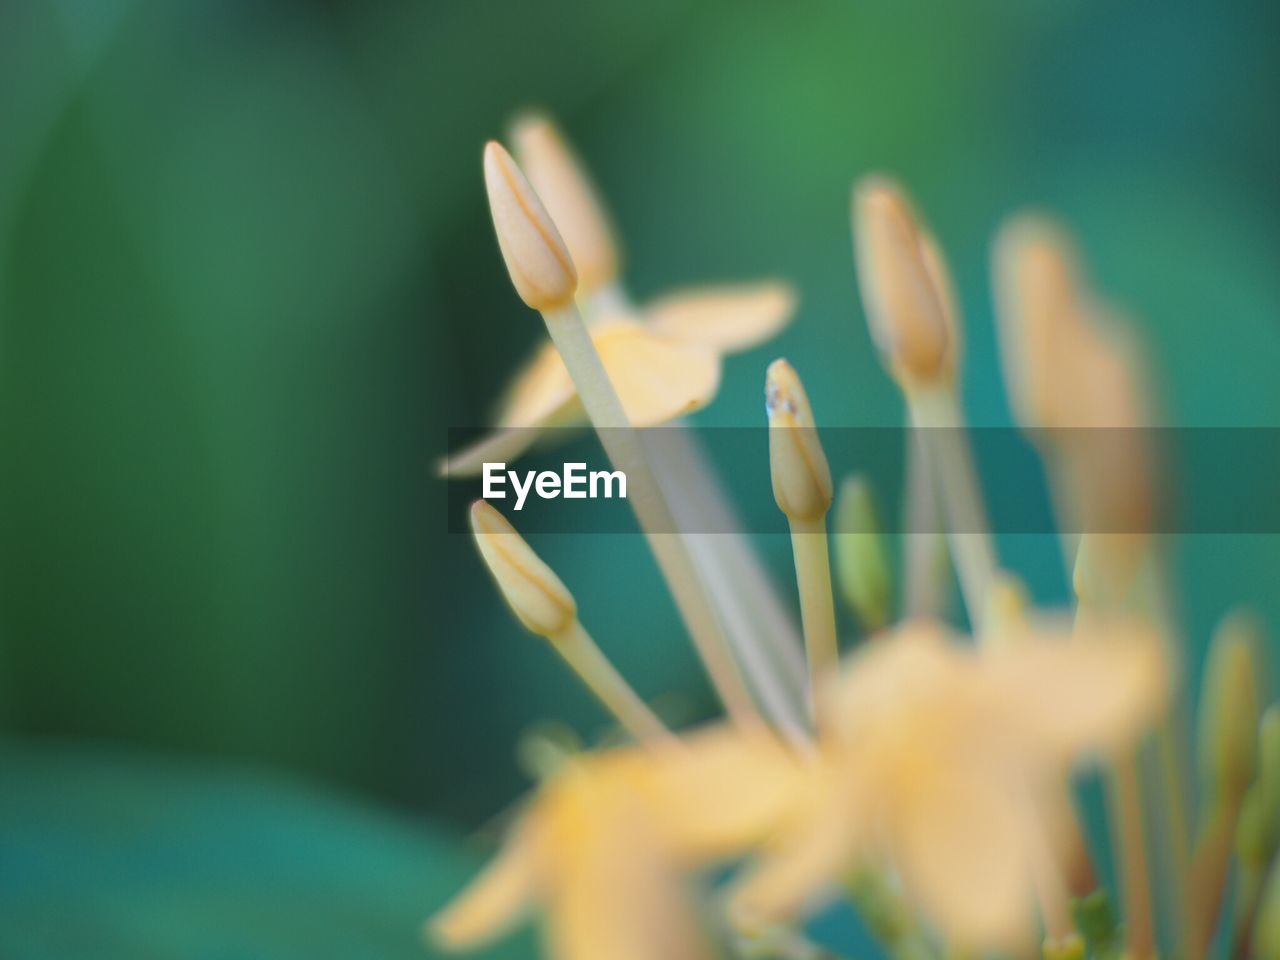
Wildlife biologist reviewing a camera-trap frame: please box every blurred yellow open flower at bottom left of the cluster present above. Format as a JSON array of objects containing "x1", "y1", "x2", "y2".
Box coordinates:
[{"x1": 428, "y1": 727, "x2": 796, "y2": 960}]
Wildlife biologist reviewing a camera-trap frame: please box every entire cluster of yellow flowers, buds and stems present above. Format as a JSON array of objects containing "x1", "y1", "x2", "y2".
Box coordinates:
[{"x1": 428, "y1": 118, "x2": 1280, "y2": 960}]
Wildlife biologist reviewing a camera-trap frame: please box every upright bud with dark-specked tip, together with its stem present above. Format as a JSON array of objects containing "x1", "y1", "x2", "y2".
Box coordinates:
[{"x1": 764, "y1": 360, "x2": 840, "y2": 721}]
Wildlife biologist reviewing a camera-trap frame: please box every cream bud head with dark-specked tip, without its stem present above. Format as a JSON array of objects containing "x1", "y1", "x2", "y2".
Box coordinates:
[{"x1": 764, "y1": 360, "x2": 832, "y2": 520}]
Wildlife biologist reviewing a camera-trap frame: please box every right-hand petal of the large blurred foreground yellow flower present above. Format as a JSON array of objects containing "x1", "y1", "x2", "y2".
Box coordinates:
[{"x1": 979, "y1": 620, "x2": 1171, "y2": 763}]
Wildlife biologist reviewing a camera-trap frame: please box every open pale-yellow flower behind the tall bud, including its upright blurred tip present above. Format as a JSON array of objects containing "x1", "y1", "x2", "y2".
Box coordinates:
[{"x1": 442, "y1": 116, "x2": 795, "y2": 477}]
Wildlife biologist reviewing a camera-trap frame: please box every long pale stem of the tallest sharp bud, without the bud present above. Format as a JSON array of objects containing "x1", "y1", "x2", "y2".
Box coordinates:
[{"x1": 543, "y1": 303, "x2": 760, "y2": 726}]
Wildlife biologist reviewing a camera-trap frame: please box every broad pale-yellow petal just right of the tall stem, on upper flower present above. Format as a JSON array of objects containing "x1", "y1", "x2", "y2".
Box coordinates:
[{"x1": 591, "y1": 323, "x2": 721, "y2": 426}]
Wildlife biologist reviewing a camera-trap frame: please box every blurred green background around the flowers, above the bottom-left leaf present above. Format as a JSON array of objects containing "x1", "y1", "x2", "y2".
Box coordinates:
[{"x1": 0, "y1": 0, "x2": 1280, "y2": 955}]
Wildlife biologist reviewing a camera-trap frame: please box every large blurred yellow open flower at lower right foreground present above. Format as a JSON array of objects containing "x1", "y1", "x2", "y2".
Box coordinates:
[{"x1": 733, "y1": 623, "x2": 1167, "y2": 950}]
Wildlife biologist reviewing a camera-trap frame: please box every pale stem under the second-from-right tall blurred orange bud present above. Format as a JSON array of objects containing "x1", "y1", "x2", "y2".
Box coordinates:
[{"x1": 908, "y1": 387, "x2": 996, "y2": 635}]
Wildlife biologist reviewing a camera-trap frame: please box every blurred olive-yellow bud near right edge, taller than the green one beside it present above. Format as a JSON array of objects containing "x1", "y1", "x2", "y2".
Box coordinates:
[{"x1": 1199, "y1": 613, "x2": 1261, "y2": 800}]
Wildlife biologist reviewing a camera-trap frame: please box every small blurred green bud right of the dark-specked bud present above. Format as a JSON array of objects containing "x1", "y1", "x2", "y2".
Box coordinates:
[{"x1": 835, "y1": 475, "x2": 893, "y2": 630}]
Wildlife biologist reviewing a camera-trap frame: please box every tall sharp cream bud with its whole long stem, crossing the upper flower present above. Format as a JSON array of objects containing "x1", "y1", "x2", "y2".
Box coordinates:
[{"x1": 485, "y1": 143, "x2": 759, "y2": 726}]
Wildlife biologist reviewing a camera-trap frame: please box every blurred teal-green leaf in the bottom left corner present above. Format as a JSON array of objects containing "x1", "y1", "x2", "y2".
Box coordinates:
[{"x1": 0, "y1": 741, "x2": 535, "y2": 960}]
